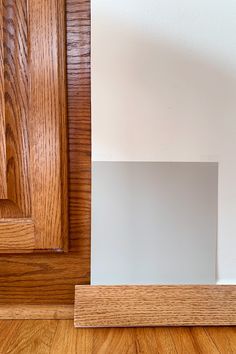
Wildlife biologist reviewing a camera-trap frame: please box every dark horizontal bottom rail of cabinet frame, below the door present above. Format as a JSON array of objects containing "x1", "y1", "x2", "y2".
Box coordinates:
[{"x1": 0, "y1": 253, "x2": 89, "y2": 305}]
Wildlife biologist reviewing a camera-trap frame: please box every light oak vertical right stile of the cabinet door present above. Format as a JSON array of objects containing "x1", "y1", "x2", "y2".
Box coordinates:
[{"x1": 28, "y1": 0, "x2": 67, "y2": 249}]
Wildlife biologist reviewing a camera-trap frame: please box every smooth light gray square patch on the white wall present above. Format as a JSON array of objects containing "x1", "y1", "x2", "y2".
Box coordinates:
[{"x1": 92, "y1": 162, "x2": 218, "y2": 284}]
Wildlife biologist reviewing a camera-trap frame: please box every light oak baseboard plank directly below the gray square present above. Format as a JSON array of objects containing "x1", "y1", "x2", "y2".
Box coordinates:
[{"x1": 74, "y1": 285, "x2": 236, "y2": 328}]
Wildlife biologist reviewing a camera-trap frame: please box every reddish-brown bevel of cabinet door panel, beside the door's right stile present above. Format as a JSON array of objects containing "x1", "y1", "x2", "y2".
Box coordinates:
[{"x1": 3, "y1": 0, "x2": 31, "y2": 217}]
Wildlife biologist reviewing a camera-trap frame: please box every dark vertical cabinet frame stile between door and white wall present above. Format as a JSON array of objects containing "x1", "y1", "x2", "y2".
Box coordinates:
[{"x1": 67, "y1": 0, "x2": 91, "y2": 252}]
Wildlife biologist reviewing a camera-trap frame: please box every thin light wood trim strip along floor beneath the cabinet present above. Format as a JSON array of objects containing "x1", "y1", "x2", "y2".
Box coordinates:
[{"x1": 0, "y1": 304, "x2": 74, "y2": 320}]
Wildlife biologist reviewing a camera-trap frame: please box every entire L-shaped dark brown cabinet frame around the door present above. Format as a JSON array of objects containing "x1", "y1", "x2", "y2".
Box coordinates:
[{"x1": 0, "y1": 0, "x2": 91, "y2": 305}]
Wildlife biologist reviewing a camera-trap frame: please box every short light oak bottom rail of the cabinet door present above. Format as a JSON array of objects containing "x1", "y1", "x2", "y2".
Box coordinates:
[{"x1": 0, "y1": 219, "x2": 35, "y2": 252}]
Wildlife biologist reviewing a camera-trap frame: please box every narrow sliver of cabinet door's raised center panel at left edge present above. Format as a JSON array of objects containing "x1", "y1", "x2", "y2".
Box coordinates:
[{"x1": 0, "y1": 0, "x2": 7, "y2": 199}]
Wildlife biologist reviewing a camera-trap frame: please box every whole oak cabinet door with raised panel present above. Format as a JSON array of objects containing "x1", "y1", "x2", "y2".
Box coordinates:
[{"x1": 0, "y1": 0, "x2": 67, "y2": 252}]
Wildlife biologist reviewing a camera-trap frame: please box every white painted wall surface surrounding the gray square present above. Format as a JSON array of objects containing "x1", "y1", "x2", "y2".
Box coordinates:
[{"x1": 92, "y1": 0, "x2": 236, "y2": 283}]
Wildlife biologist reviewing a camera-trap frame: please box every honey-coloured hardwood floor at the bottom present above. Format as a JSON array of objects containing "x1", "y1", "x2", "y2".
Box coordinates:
[{"x1": 0, "y1": 320, "x2": 236, "y2": 354}]
